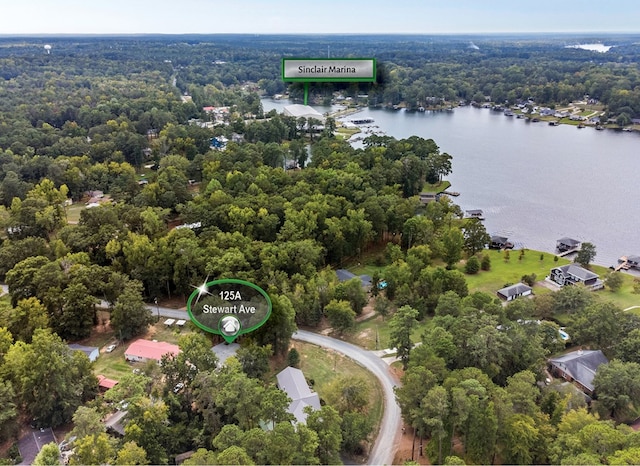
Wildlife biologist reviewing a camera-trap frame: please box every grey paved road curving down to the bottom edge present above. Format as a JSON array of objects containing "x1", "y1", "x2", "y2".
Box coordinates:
[{"x1": 292, "y1": 330, "x2": 402, "y2": 464}]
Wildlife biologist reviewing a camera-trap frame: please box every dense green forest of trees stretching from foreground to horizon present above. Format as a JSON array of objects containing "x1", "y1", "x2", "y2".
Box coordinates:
[{"x1": 0, "y1": 36, "x2": 640, "y2": 464}]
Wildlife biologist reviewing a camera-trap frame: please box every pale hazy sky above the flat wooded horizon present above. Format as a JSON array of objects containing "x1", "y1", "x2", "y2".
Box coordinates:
[{"x1": 0, "y1": 0, "x2": 640, "y2": 35}]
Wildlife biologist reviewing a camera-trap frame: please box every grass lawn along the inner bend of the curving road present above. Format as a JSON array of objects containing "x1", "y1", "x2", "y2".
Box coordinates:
[{"x1": 293, "y1": 341, "x2": 384, "y2": 440}]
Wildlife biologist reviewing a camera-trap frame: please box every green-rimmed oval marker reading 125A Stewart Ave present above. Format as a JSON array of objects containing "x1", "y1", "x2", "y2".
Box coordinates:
[{"x1": 187, "y1": 278, "x2": 272, "y2": 343}]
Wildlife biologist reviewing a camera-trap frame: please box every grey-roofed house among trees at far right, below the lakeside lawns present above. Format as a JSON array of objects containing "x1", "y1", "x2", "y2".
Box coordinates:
[{"x1": 549, "y1": 350, "x2": 609, "y2": 396}]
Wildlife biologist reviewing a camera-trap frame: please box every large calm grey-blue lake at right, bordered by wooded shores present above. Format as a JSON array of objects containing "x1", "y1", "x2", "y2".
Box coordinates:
[{"x1": 263, "y1": 100, "x2": 640, "y2": 266}]
